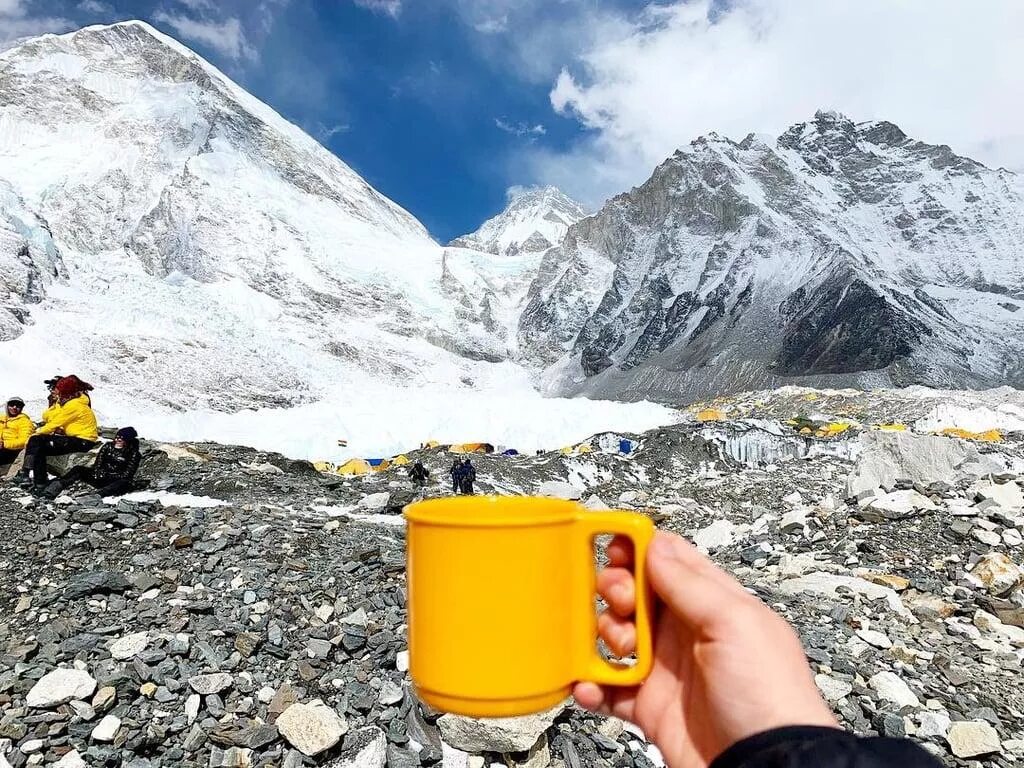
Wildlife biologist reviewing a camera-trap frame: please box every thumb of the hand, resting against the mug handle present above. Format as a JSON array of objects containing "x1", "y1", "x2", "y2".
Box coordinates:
[{"x1": 647, "y1": 530, "x2": 750, "y2": 632}]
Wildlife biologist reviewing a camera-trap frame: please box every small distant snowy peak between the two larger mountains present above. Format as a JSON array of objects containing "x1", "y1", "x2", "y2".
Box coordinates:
[{"x1": 449, "y1": 186, "x2": 587, "y2": 256}]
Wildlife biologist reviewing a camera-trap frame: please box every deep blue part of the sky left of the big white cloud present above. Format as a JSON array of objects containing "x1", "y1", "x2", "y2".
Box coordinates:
[{"x1": 0, "y1": 0, "x2": 644, "y2": 241}]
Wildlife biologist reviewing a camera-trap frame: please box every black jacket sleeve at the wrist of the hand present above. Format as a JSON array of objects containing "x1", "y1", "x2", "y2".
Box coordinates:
[{"x1": 711, "y1": 726, "x2": 942, "y2": 768}]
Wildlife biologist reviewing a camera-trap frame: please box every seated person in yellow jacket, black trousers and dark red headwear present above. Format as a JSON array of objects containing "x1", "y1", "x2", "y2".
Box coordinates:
[{"x1": 18, "y1": 376, "x2": 99, "y2": 492}]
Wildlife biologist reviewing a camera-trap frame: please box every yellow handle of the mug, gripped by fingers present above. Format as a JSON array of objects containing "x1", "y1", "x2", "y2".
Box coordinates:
[{"x1": 577, "y1": 511, "x2": 654, "y2": 686}]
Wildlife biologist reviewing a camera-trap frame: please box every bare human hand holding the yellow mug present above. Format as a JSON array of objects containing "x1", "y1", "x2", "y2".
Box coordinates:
[{"x1": 572, "y1": 531, "x2": 839, "y2": 768}]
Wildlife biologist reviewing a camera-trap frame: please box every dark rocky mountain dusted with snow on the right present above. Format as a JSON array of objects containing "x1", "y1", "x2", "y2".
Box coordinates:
[{"x1": 517, "y1": 112, "x2": 1024, "y2": 400}]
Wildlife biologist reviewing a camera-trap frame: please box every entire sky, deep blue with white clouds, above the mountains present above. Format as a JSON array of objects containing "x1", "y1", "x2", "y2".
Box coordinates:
[{"x1": 0, "y1": 0, "x2": 1024, "y2": 242}]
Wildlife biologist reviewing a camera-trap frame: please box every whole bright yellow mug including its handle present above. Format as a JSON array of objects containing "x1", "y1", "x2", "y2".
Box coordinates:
[{"x1": 406, "y1": 496, "x2": 654, "y2": 717}]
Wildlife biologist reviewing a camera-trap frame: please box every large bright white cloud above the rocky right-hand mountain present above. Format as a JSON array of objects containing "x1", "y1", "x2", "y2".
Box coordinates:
[{"x1": 527, "y1": 0, "x2": 1024, "y2": 203}]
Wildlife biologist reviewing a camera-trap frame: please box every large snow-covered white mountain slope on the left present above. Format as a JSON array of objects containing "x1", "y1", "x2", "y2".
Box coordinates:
[{"x1": 0, "y1": 22, "x2": 514, "y2": 410}]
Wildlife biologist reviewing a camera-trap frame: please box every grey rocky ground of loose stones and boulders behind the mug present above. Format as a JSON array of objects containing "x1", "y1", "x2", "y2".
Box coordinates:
[{"x1": 0, "y1": 394, "x2": 1024, "y2": 768}]
